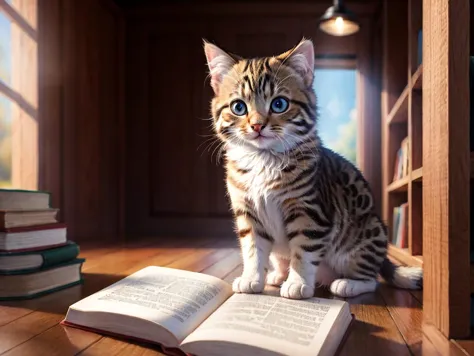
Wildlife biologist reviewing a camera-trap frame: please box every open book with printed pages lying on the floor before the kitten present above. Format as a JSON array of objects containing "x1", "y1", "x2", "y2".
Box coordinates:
[{"x1": 62, "y1": 267, "x2": 352, "y2": 356}]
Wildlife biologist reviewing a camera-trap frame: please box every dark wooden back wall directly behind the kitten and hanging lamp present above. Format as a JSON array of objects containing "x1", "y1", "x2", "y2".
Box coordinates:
[{"x1": 126, "y1": 2, "x2": 380, "y2": 237}]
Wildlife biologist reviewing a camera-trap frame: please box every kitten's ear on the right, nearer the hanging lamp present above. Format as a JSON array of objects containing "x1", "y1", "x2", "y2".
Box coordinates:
[{"x1": 278, "y1": 38, "x2": 314, "y2": 86}]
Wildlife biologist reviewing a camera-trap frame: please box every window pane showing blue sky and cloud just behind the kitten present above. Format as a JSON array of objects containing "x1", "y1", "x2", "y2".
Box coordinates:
[{"x1": 314, "y1": 68, "x2": 357, "y2": 164}]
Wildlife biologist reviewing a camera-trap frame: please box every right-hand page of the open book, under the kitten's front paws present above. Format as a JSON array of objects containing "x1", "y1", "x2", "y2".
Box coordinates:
[{"x1": 183, "y1": 294, "x2": 344, "y2": 355}]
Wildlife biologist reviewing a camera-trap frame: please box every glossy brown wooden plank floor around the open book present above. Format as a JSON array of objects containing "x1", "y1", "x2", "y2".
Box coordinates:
[{"x1": 0, "y1": 239, "x2": 468, "y2": 356}]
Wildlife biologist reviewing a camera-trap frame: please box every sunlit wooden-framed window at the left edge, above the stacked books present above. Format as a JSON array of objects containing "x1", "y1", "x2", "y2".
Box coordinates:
[{"x1": 0, "y1": 0, "x2": 38, "y2": 189}]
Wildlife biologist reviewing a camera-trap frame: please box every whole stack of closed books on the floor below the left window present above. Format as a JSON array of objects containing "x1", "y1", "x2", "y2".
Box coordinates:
[{"x1": 0, "y1": 189, "x2": 84, "y2": 300}]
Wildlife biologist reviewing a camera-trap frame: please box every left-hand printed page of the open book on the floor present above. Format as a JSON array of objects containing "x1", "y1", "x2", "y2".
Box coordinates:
[{"x1": 66, "y1": 266, "x2": 232, "y2": 341}]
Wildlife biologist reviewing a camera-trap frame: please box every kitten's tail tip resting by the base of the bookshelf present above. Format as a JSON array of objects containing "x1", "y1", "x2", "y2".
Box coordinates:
[{"x1": 380, "y1": 258, "x2": 423, "y2": 289}]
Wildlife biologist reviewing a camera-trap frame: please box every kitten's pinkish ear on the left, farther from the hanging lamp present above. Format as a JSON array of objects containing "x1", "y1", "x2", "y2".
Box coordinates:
[{"x1": 204, "y1": 40, "x2": 237, "y2": 95}]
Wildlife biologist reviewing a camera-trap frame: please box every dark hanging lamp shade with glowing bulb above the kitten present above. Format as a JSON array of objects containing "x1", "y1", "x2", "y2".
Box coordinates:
[{"x1": 319, "y1": 0, "x2": 360, "y2": 36}]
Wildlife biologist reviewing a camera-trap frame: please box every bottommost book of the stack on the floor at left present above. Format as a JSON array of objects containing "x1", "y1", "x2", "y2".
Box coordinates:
[{"x1": 0, "y1": 258, "x2": 85, "y2": 301}]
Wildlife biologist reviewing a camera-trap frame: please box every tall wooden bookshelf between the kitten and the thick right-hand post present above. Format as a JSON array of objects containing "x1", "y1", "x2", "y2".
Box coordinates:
[{"x1": 381, "y1": 0, "x2": 423, "y2": 266}]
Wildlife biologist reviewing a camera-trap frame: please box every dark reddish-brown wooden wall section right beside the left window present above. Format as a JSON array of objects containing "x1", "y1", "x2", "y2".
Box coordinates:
[{"x1": 38, "y1": 0, "x2": 124, "y2": 241}]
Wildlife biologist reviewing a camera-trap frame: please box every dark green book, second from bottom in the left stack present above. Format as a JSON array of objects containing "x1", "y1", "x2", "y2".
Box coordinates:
[{"x1": 0, "y1": 241, "x2": 80, "y2": 275}]
